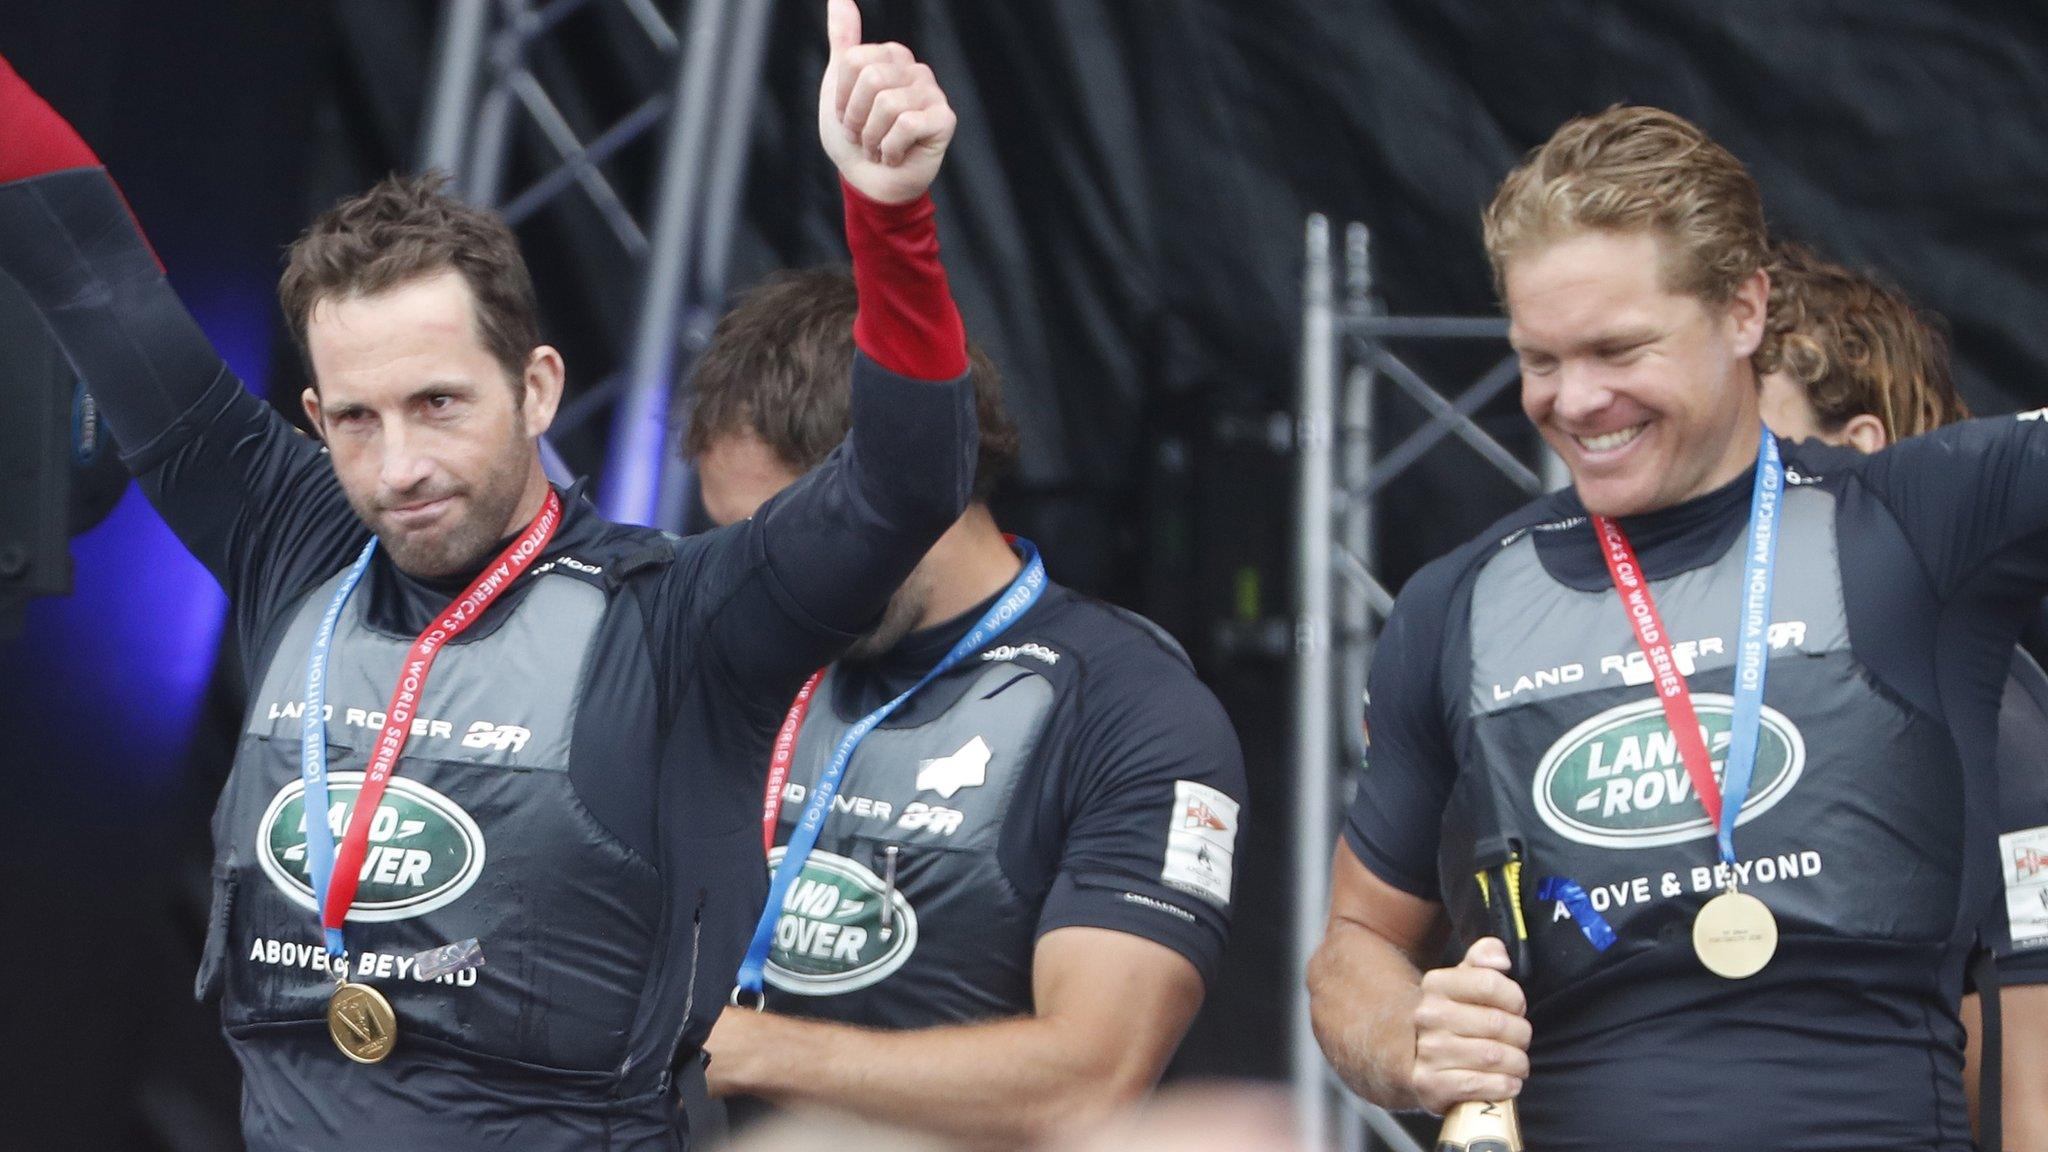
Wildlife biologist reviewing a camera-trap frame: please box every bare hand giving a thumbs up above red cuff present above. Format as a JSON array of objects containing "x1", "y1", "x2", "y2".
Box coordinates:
[{"x1": 817, "y1": 0, "x2": 956, "y2": 203}]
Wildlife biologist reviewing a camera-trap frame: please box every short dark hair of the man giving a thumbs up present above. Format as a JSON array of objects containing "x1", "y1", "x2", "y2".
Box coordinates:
[{"x1": 276, "y1": 172, "x2": 541, "y2": 387}]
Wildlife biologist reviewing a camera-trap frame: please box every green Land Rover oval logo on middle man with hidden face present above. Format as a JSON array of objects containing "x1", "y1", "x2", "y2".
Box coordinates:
[{"x1": 766, "y1": 849, "x2": 918, "y2": 996}]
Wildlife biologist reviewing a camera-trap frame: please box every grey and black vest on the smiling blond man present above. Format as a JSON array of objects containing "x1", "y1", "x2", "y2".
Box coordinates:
[{"x1": 1438, "y1": 486, "x2": 1962, "y2": 1004}]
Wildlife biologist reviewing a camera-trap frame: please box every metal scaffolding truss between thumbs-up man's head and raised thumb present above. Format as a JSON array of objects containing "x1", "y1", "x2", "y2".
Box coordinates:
[{"x1": 420, "y1": 0, "x2": 772, "y2": 529}]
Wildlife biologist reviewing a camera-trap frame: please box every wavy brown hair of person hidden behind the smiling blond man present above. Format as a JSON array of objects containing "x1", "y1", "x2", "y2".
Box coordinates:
[{"x1": 1755, "y1": 242, "x2": 1970, "y2": 443}]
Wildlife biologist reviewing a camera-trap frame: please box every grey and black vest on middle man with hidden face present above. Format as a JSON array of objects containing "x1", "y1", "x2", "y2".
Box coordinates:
[{"x1": 768, "y1": 656, "x2": 1057, "y2": 1027}]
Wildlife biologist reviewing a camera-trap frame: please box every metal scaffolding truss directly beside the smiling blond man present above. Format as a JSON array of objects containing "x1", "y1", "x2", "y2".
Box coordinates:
[{"x1": 1290, "y1": 215, "x2": 1567, "y2": 1152}]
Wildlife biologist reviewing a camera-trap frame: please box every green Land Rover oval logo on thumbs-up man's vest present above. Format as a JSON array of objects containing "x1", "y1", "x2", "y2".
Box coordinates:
[{"x1": 256, "y1": 773, "x2": 483, "y2": 922}]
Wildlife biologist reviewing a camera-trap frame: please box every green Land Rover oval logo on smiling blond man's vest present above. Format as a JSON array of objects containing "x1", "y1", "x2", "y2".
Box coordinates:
[{"x1": 1534, "y1": 693, "x2": 1806, "y2": 849}]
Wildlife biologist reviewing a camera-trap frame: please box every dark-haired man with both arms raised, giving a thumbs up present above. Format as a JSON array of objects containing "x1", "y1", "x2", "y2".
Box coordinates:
[{"x1": 0, "y1": 0, "x2": 977, "y2": 1152}]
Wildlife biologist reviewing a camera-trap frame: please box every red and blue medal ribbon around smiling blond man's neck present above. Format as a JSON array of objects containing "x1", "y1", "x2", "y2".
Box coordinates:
[{"x1": 1593, "y1": 428, "x2": 1784, "y2": 869}]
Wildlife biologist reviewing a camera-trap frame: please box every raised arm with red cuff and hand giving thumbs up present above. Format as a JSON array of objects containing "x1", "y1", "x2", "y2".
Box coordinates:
[{"x1": 713, "y1": 0, "x2": 979, "y2": 672}]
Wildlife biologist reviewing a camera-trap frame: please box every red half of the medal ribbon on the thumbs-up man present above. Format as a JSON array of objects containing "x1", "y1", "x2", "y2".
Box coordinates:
[{"x1": 315, "y1": 490, "x2": 561, "y2": 931}]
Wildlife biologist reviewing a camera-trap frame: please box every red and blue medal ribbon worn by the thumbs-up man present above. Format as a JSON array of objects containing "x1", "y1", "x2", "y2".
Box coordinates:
[{"x1": 299, "y1": 490, "x2": 561, "y2": 957}]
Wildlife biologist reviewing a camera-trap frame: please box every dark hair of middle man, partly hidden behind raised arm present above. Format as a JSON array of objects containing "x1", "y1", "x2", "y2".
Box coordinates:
[{"x1": 682, "y1": 269, "x2": 1018, "y2": 502}]
